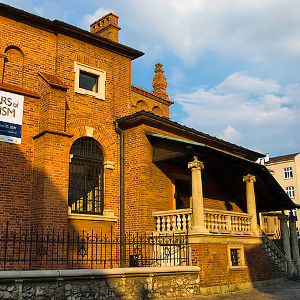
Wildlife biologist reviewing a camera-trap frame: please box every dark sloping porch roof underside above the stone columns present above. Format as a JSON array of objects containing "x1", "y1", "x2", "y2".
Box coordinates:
[{"x1": 145, "y1": 131, "x2": 296, "y2": 212}]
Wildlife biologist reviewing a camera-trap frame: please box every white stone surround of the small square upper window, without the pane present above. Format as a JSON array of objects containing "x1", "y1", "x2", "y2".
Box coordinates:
[{"x1": 74, "y1": 61, "x2": 106, "y2": 100}]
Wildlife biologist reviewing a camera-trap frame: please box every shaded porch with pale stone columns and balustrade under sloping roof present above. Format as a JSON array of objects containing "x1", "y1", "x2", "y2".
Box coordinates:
[{"x1": 145, "y1": 131, "x2": 294, "y2": 237}]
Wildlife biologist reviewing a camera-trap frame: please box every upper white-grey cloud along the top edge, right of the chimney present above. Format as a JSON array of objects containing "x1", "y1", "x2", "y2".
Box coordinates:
[{"x1": 110, "y1": 0, "x2": 300, "y2": 64}]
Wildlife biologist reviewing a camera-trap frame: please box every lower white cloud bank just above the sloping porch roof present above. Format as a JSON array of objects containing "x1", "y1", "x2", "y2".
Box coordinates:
[{"x1": 174, "y1": 72, "x2": 300, "y2": 153}]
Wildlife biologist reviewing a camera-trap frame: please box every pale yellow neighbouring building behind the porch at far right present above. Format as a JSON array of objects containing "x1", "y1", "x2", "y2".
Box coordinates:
[{"x1": 263, "y1": 152, "x2": 300, "y2": 236}]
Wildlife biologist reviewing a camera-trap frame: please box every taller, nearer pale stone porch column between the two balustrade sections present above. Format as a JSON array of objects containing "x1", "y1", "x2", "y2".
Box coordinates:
[{"x1": 188, "y1": 156, "x2": 207, "y2": 232}]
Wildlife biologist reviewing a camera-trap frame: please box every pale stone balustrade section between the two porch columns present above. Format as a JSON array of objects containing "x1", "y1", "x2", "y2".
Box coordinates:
[{"x1": 204, "y1": 209, "x2": 252, "y2": 235}]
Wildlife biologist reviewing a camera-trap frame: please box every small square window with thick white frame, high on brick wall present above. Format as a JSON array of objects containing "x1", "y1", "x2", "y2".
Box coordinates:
[{"x1": 75, "y1": 62, "x2": 106, "y2": 100}]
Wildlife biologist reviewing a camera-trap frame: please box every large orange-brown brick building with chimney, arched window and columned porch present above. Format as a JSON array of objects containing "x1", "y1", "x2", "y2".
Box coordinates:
[{"x1": 0, "y1": 4, "x2": 294, "y2": 286}]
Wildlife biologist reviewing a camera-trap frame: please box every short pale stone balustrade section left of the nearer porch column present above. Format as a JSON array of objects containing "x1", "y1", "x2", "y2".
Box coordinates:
[{"x1": 152, "y1": 208, "x2": 192, "y2": 232}]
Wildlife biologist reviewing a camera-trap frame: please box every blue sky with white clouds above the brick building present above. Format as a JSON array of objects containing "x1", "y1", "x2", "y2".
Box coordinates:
[{"x1": 2, "y1": 0, "x2": 300, "y2": 156}]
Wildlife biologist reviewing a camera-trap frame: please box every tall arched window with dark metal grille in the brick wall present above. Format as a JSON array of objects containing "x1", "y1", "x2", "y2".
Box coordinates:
[{"x1": 69, "y1": 137, "x2": 103, "y2": 214}]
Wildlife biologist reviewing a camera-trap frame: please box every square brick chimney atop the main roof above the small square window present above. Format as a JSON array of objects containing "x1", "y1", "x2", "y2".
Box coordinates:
[{"x1": 90, "y1": 13, "x2": 121, "y2": 43}]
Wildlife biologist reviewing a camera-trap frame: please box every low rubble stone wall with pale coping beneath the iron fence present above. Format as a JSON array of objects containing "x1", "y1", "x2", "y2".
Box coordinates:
[{"x1": 0, "y1": 267, "x2": 284, "y2": 300}]
